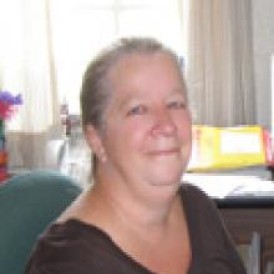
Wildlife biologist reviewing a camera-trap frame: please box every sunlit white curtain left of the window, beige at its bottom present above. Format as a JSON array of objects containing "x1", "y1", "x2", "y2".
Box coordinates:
[{"x1": 0, "y1": 0, "x2": 60, "y2": 169}]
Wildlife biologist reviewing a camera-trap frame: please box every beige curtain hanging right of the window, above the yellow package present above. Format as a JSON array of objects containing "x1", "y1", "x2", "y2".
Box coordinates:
[{"x1": 187, "y1": 0, "x2": 256, "y2": 126}]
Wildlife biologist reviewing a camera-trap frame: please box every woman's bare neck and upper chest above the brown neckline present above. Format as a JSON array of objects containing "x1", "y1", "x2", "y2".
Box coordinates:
[{"x1": 86, "y1": 178, "x2": 191, "y2": 273}]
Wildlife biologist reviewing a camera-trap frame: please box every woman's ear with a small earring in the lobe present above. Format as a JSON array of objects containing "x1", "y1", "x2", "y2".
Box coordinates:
[{"x1": 85, "y1": 125, "x2": 107, "y2": 162}]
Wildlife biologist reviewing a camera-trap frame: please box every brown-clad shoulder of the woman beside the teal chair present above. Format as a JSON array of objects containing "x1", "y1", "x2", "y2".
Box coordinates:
[{"x1": 25, "y1": 219, "x2": 155, "y2": 274}]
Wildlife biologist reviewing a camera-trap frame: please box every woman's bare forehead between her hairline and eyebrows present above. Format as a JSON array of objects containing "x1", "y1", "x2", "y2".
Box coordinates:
[{"x1": 107, "y1": 56, "x2": 185, "y2": 100}]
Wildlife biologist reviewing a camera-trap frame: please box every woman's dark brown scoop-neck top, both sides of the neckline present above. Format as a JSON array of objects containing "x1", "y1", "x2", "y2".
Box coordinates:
[{"x1": 25, "y1": 184, "x2": 246, "y2": 274}]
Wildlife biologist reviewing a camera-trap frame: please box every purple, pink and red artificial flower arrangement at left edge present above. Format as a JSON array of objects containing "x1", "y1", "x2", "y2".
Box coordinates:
[{"x1": 0, "y1": 90, "x2": 23, "y2": 183}]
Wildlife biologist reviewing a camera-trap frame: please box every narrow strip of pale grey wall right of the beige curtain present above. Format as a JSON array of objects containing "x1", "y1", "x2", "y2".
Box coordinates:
[{"x1": 251, "y1": 0, "x2": 274, "y2": 128}]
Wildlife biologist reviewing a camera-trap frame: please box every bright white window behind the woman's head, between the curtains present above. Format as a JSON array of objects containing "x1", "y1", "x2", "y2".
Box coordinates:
[{"x1": 50, "y1": 0, "x2": 186, "y2": 114}]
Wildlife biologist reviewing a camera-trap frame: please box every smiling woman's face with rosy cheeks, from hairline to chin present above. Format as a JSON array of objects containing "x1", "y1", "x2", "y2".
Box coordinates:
[{"x1": 89, "y1": 53, "x2": 191, "y2": 191}]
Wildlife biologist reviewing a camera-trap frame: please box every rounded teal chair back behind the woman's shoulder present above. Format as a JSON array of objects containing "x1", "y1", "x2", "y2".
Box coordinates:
[{"x1": 0, "y1": 170, "x2": 81, "y2": 274}]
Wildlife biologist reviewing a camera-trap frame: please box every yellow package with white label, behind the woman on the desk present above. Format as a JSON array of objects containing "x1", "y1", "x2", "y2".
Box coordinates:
[{"x1": 187, "y1": 125, "x2": 267, "y2": 171}]
